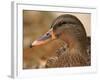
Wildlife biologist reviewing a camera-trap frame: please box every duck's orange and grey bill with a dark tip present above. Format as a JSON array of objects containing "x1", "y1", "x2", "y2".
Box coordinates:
[{"x1": 30, "y1": 28, "x2": 56, "y2": 48}]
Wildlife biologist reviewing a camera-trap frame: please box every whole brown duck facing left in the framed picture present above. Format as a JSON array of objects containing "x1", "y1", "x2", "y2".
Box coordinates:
[{"x1": 30, "y1": 14, "x2": 91, "y2": 68}]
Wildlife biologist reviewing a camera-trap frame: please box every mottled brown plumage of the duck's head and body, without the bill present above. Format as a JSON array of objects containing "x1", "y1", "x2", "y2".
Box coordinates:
[{"x1": 46, "y1": 15, "x2": 91, "y2": 68}]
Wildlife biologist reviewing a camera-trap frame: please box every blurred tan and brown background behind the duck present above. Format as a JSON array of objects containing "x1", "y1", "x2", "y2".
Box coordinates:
[{"x1": 23, "y1": 10, "x2": 91, "y2": 69}]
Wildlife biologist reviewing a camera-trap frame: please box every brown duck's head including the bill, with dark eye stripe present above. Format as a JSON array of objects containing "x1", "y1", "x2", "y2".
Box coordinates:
[{"x1": 30, "y1": 14, "x2": 86, "y2": 48}]
